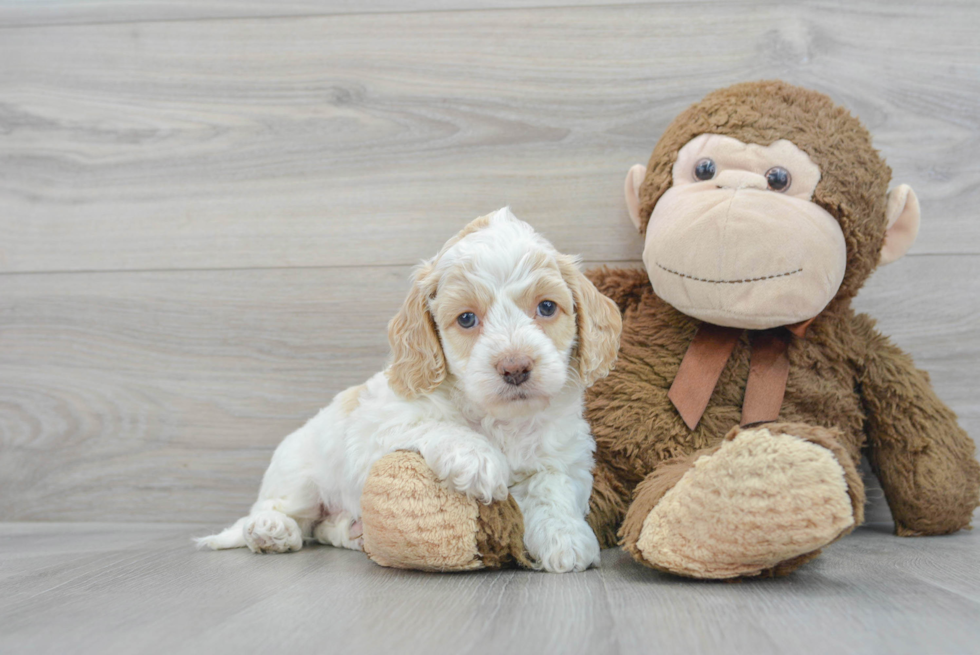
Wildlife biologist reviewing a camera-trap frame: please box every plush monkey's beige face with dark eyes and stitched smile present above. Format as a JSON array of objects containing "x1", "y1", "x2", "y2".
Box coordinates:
[{"x1": 643, "y1": 134, "x2": 847, "y2": 329}]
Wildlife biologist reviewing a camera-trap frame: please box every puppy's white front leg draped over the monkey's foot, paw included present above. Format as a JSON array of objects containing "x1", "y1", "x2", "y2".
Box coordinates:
[{"x1": 411, "y1": 421, "x2": 510, "y2": 505}]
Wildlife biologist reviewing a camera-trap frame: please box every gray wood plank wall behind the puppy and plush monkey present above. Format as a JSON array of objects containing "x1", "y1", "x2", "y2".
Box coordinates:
[{"x1": 0, "y1": 0, "x2": 980, "y2": 522}]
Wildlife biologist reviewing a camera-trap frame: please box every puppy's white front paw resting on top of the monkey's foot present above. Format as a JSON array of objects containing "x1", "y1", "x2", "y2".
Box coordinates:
[{"x1": 426, "y1": 444, "x2": 510, "y2": 505}]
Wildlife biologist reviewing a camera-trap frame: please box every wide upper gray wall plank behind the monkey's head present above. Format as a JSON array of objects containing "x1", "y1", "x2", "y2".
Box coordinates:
[{"x1": 0, "y1": 1, "x2": 980, "y2": 272}]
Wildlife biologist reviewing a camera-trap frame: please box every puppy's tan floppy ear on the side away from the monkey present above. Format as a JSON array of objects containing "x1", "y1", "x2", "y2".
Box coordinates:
[{"x1": 387, "y1": 262, "x2": 446, "y2": 399}]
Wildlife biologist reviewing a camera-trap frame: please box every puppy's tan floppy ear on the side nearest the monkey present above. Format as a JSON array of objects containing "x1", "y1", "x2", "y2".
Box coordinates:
[{"x1": 558, "y1": 255, "x2": 623, "y2": 387}]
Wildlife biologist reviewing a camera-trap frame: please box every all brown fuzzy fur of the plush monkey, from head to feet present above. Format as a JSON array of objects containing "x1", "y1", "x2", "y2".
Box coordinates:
[{"x1": 360, "y1": 82, "x2": 980, "y2": 577}]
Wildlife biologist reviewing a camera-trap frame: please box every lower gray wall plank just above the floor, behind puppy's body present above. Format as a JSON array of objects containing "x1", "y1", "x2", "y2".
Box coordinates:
[{"x1": 0, "y1": 254, "x2": 980, "y2": 522}]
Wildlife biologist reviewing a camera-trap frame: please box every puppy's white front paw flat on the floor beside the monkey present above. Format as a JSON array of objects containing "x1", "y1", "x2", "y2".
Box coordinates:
[{"x1": 524, "y1": 519, "x2": 599, "y2": 573}]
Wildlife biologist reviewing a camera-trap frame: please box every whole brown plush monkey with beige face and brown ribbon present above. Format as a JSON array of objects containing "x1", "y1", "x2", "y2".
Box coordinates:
[{"x1": 364, "y1": 82, "x2": 980, "y2": 578}]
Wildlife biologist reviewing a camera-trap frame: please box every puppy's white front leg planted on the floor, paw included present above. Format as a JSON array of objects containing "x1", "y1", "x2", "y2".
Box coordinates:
[{"x1": 511, "y1": 470, "x2": 599, "y2": 573}]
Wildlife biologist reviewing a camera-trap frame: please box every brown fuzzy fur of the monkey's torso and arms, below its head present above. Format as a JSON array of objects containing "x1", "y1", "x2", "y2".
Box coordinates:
[{"x1": 587, "y1": 268, "x2": 980, "y2": 547}]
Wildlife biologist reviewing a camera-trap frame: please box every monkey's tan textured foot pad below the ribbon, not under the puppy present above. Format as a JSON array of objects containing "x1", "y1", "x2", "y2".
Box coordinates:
[{"x1": 629, "y1": 424, "x2": 863, "y2": 579}]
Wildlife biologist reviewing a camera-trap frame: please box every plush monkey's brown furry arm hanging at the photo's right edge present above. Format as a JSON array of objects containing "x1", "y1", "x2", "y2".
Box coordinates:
[{"x1": 855, "y1": 314, "x2": 980, "y2": 537}]
